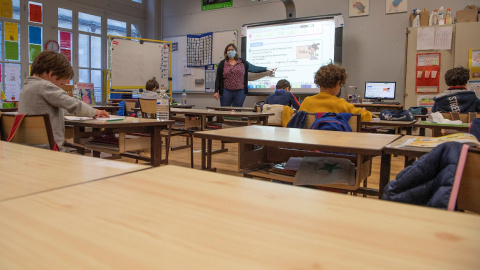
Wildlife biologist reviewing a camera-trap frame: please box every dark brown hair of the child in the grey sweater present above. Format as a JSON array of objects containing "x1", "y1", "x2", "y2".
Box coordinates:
[{"x1": 30, "y1": 51, "x2": 75, "y2": 79}]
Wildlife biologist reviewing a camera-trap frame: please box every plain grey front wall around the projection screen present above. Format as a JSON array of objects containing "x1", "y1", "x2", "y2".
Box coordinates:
[{"x1": 162, "y1": 0, "x2": 479, "y2": 108}]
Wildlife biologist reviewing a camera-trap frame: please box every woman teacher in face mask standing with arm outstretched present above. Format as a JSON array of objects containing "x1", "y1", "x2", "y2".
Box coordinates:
[{"x1": 213, "y1": 43, "x2": 275, "y2": 107}]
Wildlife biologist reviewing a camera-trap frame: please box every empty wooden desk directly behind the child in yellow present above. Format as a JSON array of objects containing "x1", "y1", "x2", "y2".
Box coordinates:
[{"x1": 193, "y1": 126, "x2": 400, "y2": 194}]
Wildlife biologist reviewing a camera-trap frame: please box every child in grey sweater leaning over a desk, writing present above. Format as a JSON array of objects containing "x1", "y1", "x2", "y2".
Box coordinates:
[{"x1": 18, "y1": 51, "x2": 109, "y2": 151}]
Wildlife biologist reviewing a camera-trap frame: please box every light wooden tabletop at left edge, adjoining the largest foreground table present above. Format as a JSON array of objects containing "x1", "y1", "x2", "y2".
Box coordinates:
[{"x1": 0, "y1": 141, "x2": 150, "y2": 201}]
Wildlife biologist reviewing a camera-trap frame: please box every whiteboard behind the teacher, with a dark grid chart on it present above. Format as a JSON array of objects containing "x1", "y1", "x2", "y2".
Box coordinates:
[{"x1": 164, "y1": 30, "x2": 238, "y2": 93}]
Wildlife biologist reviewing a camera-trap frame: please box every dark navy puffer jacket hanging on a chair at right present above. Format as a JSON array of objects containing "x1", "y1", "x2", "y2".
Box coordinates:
[{"x1": 382, "y1": 142, "x2": 462, "y2": 209}]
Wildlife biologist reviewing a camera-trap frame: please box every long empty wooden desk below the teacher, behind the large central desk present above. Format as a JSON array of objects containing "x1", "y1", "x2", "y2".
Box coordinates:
[{"x1": 171, "y1": 108, "x2": 273, "y2": 130}]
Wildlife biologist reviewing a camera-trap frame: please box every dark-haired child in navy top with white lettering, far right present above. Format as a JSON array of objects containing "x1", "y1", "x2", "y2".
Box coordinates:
[{"x1": 432, "y1": 66, "x2": 480, "y2": 113}]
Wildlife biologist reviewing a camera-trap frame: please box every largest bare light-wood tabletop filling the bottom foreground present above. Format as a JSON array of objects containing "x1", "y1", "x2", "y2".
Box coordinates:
[{"x1": 0, "y1": 165, "x2": 480, "y2": 270}]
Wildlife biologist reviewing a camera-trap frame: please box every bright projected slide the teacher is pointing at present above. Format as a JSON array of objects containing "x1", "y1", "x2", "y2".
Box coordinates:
[{"x1": 246, "y1": 18, "x2": 335, "y2": 92}]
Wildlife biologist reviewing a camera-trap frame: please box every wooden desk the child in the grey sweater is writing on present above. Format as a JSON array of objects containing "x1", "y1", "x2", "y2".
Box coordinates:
[{"x1": 65, "y1": 117, "x2": 175, "y2": 166}]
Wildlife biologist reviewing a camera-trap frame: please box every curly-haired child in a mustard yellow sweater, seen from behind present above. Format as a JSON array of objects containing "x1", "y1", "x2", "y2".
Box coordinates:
[{"x1": 299, "y1": 64, "x2": 372, "y2": 121}]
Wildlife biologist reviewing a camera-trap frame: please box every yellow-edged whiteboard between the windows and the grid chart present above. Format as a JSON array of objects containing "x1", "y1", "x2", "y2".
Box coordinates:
[{"x1": 110, "y1": 38, "x2": 171, "y2": 89}]
